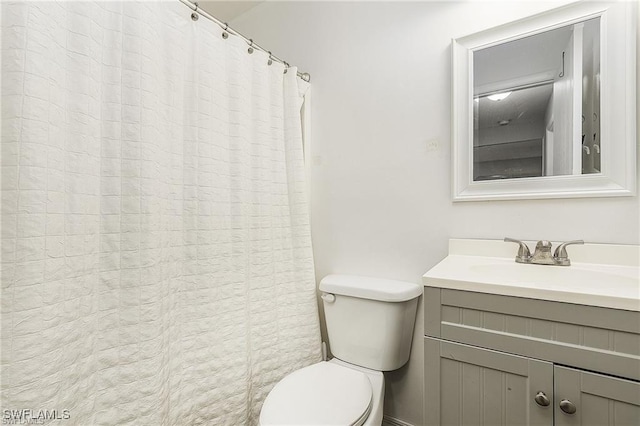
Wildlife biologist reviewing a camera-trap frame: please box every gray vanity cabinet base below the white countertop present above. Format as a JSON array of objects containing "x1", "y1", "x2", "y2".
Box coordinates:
[{"x1": 424, "y1": 287, "x2": 640, "y2": 426}]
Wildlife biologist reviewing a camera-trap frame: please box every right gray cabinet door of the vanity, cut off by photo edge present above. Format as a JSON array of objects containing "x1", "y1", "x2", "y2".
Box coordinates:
[{"x1": 554, "y1": 366, "x2": 640, "y2": 426}]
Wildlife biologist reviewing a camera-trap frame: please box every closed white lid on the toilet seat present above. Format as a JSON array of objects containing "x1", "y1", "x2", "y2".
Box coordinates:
[{"x1": 260, "y1": 362, "x2": 373, "y2": 426}]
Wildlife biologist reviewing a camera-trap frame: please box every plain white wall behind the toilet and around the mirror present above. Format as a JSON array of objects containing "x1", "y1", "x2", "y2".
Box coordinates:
[{"x1": 232, "y1": 1, "x2": 640, "y2": 425}]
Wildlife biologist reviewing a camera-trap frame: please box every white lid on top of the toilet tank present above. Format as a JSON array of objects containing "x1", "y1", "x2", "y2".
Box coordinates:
[{"x1": 320, "y1": 274, "x2": 422, "y2": 302}]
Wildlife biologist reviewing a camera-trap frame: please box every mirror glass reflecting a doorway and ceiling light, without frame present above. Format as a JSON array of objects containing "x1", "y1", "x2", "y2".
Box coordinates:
[{"x1": 473, "y1": 17, "x2": 606, "y2": 181}]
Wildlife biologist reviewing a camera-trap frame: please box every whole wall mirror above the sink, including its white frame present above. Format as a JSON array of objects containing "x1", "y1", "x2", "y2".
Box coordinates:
[{"x1": 452, "y1": 2, "x2": 637, "y2": 201}]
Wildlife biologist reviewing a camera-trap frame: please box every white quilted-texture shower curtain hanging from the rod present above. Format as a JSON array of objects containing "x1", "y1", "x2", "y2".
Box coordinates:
[{"x1": 1, "y1": 0, "x2": 320, "y2": 425}]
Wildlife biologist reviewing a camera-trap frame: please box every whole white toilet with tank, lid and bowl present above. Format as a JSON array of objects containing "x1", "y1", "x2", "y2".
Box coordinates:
[{"x1": 260, "y1": 275, "x2": 422, "y2": 426}]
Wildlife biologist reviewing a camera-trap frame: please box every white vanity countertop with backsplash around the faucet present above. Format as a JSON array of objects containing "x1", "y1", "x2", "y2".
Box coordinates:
[{"x1": 423, "y1": 239, "x2": 640, "y2": 311}]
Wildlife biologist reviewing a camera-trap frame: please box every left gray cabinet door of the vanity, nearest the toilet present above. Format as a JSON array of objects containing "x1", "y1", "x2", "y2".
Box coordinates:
[{"x1": 424, "y1": 337, "x2": 553, "y2": 426}]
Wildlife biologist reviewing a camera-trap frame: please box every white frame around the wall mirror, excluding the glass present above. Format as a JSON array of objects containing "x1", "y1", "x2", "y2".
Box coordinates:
[{"x1": 451, "y1": 1, "x2": 638, "y2": 201}]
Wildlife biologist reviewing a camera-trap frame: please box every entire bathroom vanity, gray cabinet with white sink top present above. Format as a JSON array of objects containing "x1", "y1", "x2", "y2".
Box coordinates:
[{"x1": 423, "y1": 240, "x2": 640, "y2": 426}]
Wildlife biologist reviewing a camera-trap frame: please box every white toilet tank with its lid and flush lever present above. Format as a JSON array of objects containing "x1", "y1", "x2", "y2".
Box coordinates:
[{"x1": 320, "y1": 275, "x2": 422, "y2": 371}]
